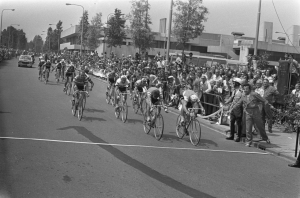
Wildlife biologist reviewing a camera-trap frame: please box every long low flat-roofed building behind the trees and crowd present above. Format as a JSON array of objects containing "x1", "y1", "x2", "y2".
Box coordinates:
[{"x1": 60, "y1": 22, "x2": 300, "y2": 65}]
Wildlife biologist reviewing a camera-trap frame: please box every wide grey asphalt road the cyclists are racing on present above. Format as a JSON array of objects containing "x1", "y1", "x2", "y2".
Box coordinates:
[{"x1": 0, "y1": 59, "x2": 300, "y2": 198}]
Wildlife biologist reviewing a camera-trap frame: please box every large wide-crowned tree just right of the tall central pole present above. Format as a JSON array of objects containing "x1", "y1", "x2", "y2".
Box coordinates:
[{"x1": 172, "y1": 0, "x2": 208, "y2": 52}]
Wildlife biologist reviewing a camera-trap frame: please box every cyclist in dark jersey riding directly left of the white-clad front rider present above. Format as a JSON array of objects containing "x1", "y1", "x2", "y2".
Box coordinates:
[{"x1": 146, "y1": 82, "x2": 168, "y2": 122}]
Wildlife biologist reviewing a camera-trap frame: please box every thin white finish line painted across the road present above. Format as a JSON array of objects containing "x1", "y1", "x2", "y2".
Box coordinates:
[{"x1": 0, "y1": 137, "x2": 270, "y2": 155}]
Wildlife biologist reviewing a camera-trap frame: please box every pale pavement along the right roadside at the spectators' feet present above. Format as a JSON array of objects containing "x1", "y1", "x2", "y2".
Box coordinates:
[{"x1": 94, "y1": 73, "x2": 299, "y2": 162}]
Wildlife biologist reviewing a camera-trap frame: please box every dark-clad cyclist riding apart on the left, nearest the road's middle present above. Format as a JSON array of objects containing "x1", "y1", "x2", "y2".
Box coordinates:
[{"x1": 72, "y1": 67, "x2": 94, "y2": 105}]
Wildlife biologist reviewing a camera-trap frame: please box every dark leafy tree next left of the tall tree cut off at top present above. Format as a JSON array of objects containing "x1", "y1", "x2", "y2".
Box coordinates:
[{"x1": 105, "y1": 9, "x2": 126, "y2": 47}]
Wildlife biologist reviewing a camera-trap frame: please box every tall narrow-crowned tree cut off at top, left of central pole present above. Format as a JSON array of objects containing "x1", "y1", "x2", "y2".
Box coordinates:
[{"x1": 128, "y1": 0, "x2": 154, "y2": 52}]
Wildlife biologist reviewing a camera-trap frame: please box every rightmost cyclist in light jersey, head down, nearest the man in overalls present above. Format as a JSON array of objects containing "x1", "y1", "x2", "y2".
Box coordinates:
[{"x1": 180, "y1": 90, "x2": 204, "y2": 131}]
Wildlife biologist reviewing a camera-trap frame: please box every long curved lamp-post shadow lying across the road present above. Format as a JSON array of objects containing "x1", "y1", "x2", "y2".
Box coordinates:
[{"x1": 57, "y1": 126, "x2": 213, "y2": 198}]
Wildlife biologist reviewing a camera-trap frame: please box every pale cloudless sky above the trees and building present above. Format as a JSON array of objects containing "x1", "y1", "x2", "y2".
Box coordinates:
[{"x1": 0, "y1": 0, "x2": 300, "y2": 41}]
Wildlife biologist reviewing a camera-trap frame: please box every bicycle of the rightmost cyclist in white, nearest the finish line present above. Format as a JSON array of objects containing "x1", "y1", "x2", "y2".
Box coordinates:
[{"x1": 176, "y1": 108, "x2": 201, "y2": 146}]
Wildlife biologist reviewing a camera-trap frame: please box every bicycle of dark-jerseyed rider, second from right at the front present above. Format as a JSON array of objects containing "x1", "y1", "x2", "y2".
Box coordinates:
[{"x1": 143, "y1": 105, "x2": 165, "y2": 140}]
